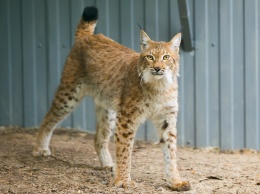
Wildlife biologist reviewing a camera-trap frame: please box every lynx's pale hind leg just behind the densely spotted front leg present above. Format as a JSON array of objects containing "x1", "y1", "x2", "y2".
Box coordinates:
[{"x1": 95, "y1": 103, "x2": 116, "y2": 170}]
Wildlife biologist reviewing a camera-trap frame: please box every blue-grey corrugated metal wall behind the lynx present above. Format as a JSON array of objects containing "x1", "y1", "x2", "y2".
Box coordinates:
[{"x1": 0, "y1": 0, "x2": 260, "y2": 149}]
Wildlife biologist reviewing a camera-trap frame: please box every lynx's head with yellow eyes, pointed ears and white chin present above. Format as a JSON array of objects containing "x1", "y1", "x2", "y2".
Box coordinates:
[{"x1": 138, "y1": 30, "x2": 181, "y2": 89}]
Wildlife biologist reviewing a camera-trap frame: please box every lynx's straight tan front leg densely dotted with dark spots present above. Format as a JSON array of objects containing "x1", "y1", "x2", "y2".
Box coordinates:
[{"x1": 115, "y1": 113, "x2": 136, "y2": 188}]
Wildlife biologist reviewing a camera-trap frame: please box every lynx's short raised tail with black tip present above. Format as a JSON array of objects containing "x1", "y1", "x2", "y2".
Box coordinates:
[{"x1": 76, "y1": 7, "x2": 98, "y2": 39}]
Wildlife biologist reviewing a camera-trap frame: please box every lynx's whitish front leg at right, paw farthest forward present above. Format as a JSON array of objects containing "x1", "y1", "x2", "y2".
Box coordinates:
[{"x1": 156, "y1": 115, "x2": 191, "y2": 191}]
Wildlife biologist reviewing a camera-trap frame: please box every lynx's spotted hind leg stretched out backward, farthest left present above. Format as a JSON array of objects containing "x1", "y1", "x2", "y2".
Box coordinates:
[{"x1": 32, "y1": 84, "x2": 83, "y2": 157}]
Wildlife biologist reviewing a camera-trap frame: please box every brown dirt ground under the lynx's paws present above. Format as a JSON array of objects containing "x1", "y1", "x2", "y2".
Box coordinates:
[{"x1": 0, "y1": 127, "x2": 260, "y2": 194}]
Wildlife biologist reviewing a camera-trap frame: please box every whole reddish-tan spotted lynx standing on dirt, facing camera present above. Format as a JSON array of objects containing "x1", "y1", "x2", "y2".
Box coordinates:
[{"x1": 33, "y1": 7, "x2": 190, "y2": 191}]
